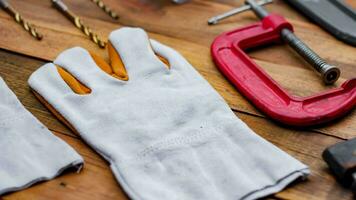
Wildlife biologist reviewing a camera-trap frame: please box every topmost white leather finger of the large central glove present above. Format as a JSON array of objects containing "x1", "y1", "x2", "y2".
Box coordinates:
[{"x1": 109, "y1": 28, "x2": 169, "y2": 79}]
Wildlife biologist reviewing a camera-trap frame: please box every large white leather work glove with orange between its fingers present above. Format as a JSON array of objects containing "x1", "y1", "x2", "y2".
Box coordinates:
[{"x1": 29, "y1": 28, "x2": 309, "y2": 200}]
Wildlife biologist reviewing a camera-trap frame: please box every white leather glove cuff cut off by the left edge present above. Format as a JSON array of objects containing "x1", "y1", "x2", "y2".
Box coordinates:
[{"x1": 0, "y1": 77, "x2": 83, "y2": 195}]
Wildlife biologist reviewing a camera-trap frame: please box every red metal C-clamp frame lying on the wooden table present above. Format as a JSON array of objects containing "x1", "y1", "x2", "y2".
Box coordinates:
[{"x1": 211, "y1": 0, "x2": 356, "y2": 126}]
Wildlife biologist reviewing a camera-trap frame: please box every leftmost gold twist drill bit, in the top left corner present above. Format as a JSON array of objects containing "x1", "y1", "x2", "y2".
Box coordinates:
[{"x1": 0, "y1": 0, "x2": 43, "y2": 40}]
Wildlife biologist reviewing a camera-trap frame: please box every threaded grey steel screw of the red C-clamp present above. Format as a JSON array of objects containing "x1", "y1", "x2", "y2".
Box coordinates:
[{"x1": 246, "y1": 0, "x2": 340, "y2": 85}]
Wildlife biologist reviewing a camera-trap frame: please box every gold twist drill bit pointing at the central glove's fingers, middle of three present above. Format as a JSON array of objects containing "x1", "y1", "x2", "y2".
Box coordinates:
[{"x1": 52, "y1": 0, "x2": 106, "y2": 48}]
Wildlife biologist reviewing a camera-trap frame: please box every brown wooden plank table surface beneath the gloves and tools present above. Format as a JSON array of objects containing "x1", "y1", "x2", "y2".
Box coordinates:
[{"x1": 0, "y1": 0, "x2": 356, "y2": 200}]
